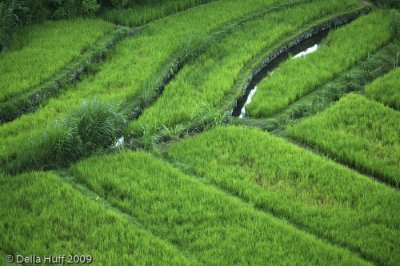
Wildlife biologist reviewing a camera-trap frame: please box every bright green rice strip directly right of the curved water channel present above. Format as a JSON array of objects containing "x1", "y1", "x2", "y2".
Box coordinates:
[{"x1": 246, "y1": 11, "x2": 391, "y2": 117}]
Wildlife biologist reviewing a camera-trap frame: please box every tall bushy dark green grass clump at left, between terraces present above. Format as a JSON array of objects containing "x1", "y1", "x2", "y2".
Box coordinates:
[{"x1": 2, "y1": 99, "x2": 127, "y2": 173}]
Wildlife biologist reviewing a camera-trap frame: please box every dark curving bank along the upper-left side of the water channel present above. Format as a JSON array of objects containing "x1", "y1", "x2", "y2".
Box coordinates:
[{"x1": 231, "y1": 7, "x2": 372, "y2": 117}]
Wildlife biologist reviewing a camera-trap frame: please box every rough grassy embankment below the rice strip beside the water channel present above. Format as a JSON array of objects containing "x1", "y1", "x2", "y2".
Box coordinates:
[{"x1": 231, "y1": 42, "x2": 399, "y2": 135}]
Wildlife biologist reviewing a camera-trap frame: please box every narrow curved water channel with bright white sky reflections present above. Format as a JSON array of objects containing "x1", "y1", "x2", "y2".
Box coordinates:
[{"x1": 232, "y1": 19, "x2": 351, "y2": 118}]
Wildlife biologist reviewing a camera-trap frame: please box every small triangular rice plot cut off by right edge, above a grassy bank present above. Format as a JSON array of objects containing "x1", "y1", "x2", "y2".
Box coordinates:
[{"x1": 365, "y1": 67, "x2": 400, "y2": 110}]
